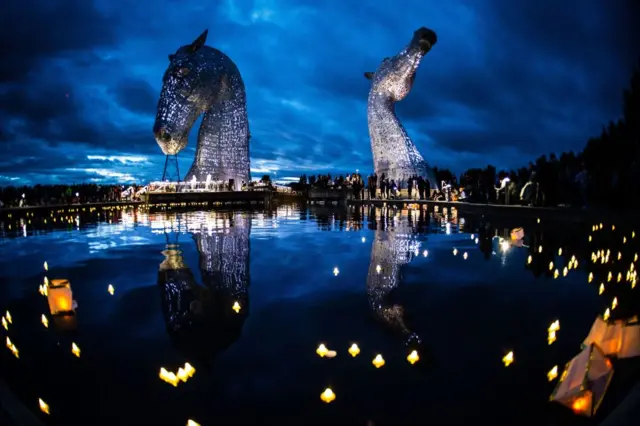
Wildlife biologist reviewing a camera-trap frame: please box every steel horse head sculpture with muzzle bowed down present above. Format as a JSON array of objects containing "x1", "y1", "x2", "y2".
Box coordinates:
[{"x1": 153, "y1": 31, "x2": 250, "y2": 189}]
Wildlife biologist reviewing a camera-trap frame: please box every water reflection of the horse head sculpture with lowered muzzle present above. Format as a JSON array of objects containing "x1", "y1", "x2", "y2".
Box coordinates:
[{"x1": 158, "y1": 212, "x2": 251, "y2": 363}]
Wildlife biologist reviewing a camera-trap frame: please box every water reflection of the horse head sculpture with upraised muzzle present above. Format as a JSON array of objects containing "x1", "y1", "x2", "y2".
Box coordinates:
[{"x1": 367, "y1": 207, "x2": 422, "y2": 349}]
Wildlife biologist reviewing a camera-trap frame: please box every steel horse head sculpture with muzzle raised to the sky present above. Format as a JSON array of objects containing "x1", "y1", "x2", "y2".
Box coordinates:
[{"x1": 364, "y1": 27, "x2": 438, "y2": 188}]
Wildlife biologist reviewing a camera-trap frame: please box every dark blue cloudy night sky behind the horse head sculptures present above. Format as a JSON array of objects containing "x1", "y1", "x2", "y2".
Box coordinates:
[{"x1": 0, "y1": 0, "x2": 640, "y2": 185}]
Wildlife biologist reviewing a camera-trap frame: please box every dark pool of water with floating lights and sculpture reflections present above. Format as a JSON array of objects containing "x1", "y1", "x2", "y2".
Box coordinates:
[{"x1": 0, "y1": 206, "x2": 640, "y2": 426}]
